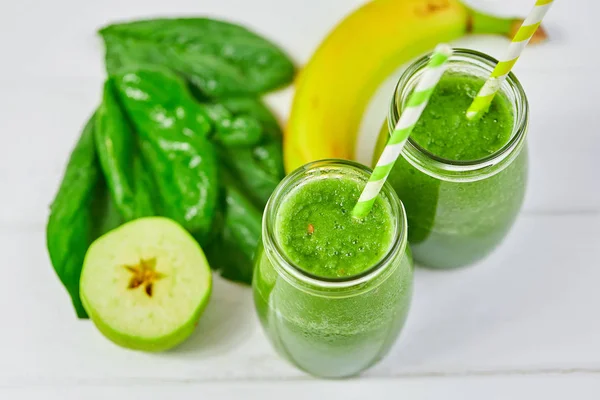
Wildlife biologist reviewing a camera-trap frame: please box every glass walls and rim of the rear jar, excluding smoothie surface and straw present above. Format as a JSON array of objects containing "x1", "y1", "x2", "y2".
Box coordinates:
[{"x1": 374, "y1": 49, "x2": 529, "y2": 268}]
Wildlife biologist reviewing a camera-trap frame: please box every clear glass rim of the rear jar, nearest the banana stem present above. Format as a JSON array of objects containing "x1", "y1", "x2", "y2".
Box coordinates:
[{"x1": 388, "y1": 48, "x2": 529, "y2": 181}]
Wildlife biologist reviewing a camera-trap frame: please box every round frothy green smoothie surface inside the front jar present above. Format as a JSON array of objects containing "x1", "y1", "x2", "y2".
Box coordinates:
[{"x1": 276, "y1": 176, "x2": 395, "y2": 278}]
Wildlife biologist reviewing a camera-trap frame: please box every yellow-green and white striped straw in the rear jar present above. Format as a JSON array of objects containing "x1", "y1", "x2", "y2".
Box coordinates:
[{"x1": 467, "y1": 0, "x2": 554, "y2": 120}]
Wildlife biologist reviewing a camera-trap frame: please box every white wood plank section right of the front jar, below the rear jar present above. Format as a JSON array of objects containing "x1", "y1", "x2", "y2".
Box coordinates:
[{"x1": 373, "y1": 215, "x2": 600, "y2": 374}]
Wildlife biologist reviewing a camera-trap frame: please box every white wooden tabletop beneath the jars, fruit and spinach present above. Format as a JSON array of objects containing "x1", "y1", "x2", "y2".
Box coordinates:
[{"x1": 0, "y1": 0, "x2": 600, "y2": 400}]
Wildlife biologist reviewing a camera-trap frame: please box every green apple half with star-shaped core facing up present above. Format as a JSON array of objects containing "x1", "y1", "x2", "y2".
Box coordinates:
[{"x1": 79, "y1": 217, "x2": 212, "y2": 351}]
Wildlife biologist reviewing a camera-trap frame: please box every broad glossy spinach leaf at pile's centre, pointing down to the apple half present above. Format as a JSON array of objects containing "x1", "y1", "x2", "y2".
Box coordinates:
[{"x1": 113, "y1": 68, "x2": 219, "y2": 243}]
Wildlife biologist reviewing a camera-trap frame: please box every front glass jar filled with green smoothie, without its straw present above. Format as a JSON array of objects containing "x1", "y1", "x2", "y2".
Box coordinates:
[{"x1": 253, "y1": 160, "x2": 413, "y2": 378}]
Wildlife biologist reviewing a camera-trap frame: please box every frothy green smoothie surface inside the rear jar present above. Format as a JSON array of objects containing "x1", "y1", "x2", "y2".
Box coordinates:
[{"x1": 411, "y1": 72, "x2": 514, "y2": 161}]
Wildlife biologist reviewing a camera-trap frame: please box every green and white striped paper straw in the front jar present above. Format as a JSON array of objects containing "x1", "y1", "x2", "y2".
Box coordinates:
[{"x1": 352, "y1": 44, "x2": 452, "y2": 218}]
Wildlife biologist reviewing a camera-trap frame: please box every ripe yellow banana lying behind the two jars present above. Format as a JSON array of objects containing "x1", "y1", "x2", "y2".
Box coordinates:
[{"x1": 284, "y1": 0, "x2": 545, "y2": 172}]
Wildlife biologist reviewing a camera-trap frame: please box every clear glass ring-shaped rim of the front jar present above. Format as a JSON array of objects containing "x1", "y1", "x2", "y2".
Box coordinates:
[{"x1": 262, "y1": 159, "x2": 408, "y2": 290}]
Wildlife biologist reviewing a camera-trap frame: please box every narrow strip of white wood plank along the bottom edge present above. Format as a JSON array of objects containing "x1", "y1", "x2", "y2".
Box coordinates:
[{"x1": 0, "y1": 374, "x2": 600, "y2": 400}]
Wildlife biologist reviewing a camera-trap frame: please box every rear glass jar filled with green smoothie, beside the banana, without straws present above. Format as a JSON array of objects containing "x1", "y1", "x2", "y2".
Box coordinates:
[{"x1": 374, "y1": 49, "x2": 529, "y2": 268}]
